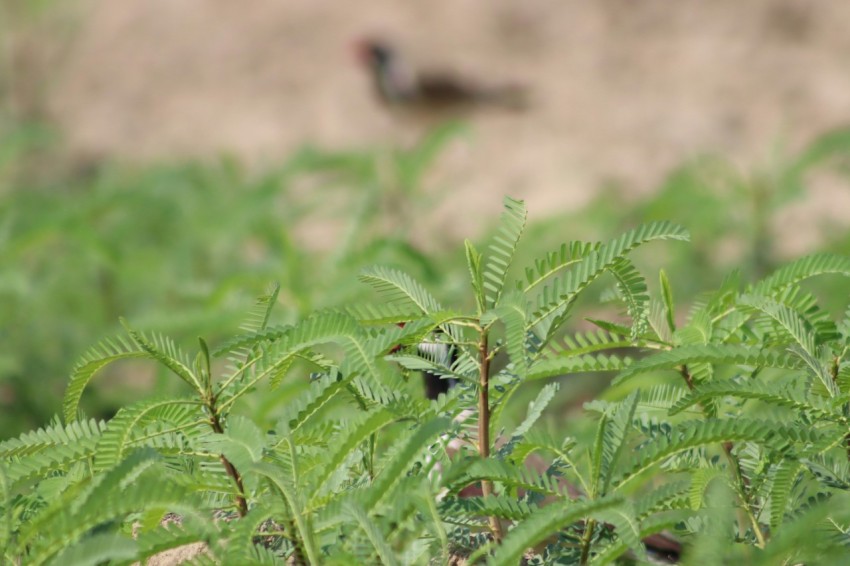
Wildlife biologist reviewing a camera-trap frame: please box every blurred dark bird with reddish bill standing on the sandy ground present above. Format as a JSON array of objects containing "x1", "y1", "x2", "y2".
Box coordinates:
[{"x1": 356, "y1": 39, "x2": 527, "y2": 112}]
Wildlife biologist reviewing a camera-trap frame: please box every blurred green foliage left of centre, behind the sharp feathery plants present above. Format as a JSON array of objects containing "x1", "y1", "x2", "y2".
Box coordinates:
[{"x1": 0, "y1": 125, "x2": 461, "y2": 439}]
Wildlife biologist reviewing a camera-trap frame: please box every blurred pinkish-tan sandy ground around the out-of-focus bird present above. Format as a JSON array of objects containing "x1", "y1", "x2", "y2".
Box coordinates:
[{"x1": 31, "y1": 0, "x2": 850, "y2": 241}]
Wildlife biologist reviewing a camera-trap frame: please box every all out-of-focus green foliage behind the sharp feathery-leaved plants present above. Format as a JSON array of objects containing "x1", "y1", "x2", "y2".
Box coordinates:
[{"x1": 8, "y1": 125, "x2": 850, "y2": 438}]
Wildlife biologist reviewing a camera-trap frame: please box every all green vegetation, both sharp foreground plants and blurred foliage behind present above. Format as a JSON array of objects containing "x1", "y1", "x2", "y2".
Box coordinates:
[{"x1": 0, "y1": 17, "x2": 850, "y2": 565}]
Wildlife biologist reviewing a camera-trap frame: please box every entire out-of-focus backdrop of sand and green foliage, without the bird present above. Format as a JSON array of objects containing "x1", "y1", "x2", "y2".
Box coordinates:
[{"x1": 0, "y1": 0, "x2": 850, "y2": 438}]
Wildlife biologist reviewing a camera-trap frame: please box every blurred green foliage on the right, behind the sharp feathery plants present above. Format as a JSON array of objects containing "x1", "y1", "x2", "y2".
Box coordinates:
[{"x1": 522, "y1": 127, "x2": 850, "y2": 308}]
